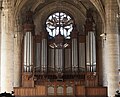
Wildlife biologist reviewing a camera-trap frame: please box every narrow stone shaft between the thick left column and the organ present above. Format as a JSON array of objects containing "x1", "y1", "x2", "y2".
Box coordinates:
[{"x1": 14, "y1": 18, "x2": 22, "y2": 87}]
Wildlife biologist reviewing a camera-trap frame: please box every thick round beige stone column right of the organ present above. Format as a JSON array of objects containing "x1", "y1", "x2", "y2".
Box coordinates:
[{"x1": 103, "y1": 0, "x2": 119, "y2": 97}]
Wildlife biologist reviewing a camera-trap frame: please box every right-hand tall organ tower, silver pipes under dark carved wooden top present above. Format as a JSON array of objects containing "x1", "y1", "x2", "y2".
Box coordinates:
[{"x1": 85, "y1": 9, "x2": 96, "y2": 72}]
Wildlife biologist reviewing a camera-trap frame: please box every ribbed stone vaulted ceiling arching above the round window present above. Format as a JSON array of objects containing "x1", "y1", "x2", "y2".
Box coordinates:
[{"x1": 14, "y1": 0, "x2": 103, "y2": 15}]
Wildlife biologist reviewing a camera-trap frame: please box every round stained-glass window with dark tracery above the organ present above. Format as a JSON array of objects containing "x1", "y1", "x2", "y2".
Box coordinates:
[{"x1": 45, "y1": 11, "x2": 74, "y2": 39}]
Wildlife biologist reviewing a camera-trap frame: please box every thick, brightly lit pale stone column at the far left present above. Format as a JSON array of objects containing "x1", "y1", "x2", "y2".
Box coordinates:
[{"x1": 1, "y1": 0, "x2": 14, "y2": 93}]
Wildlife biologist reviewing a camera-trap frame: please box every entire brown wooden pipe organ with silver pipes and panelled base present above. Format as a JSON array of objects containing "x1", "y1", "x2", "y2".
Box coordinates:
[{"x1": 14, "y1": 10, "x2": 107, "y2": 97}]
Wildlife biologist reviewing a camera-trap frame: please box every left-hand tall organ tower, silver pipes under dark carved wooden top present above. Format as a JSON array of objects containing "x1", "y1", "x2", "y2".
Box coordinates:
[{"x1": 23, "y1": 11, "x2": 34, "y2": 72}]
